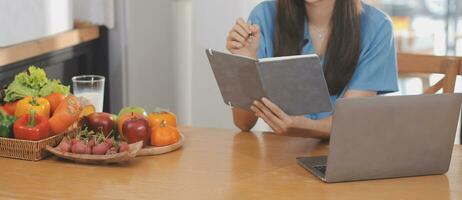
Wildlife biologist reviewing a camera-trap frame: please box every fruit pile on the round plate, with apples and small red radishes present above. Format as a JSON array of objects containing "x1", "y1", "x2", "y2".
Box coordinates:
[{"x1": 57, "y1": 107, "x2": 180, "y2": 155}]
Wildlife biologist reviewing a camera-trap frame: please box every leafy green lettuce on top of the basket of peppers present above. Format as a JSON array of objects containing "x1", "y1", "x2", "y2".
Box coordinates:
[{"x1": 3, "y1": 66, "x2": 69, "y2": 102}]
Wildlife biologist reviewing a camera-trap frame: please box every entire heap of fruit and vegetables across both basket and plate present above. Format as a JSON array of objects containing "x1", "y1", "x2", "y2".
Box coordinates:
[{"x1": 0, "y1": 66, "x2": 180, "y2": 158}]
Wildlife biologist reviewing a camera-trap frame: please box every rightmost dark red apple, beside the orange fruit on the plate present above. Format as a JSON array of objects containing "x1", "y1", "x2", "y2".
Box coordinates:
[{"x1": 120, "y1": 115, "x2": 151, "y2": 146}]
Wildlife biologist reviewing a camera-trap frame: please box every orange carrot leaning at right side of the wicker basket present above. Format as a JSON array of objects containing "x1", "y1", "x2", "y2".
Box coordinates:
[{"x1": 49, "y1": 95, "x2": 80, "y2": 134}]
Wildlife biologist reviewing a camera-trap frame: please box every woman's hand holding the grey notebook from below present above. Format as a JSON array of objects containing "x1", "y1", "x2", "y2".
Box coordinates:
[{"x1": 250, "y1": 98, "x2": 295, "y2": 134}]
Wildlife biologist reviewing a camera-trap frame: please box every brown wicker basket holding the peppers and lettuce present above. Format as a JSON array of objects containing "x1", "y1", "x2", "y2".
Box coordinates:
[{"x1": 0, "y1": 128, "x2": 78, "y2": 161}]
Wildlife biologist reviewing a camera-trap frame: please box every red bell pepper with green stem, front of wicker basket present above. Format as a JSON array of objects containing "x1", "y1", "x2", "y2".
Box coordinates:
[{"x1": 13, "y1": 110, "x2": 50, "y2": 141}]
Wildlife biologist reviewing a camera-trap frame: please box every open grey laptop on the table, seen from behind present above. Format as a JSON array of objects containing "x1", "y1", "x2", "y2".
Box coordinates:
[{"x1": 297, "y1": 94, "x2": 462, "y2": 182}]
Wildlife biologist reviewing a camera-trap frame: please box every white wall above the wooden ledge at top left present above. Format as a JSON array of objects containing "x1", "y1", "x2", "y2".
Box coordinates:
[{"x1": 0, "y1": 0, "x2": 73, "y2": 47}]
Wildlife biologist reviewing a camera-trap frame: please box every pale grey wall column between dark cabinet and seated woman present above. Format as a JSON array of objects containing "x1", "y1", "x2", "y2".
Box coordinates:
[{"x1": 114, "y1": 0, "x2": 192, "y2": 125}]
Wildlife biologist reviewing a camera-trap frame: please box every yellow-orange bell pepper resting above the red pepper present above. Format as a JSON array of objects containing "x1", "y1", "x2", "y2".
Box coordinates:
[{"x1": 14, "y1": 96, "x2": 50, "y2": 119}]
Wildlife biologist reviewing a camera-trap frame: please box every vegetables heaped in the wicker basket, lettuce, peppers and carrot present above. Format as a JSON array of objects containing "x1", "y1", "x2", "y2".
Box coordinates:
[{"x1": 0, "y1": 66, "x2": 83, "y2": 141}]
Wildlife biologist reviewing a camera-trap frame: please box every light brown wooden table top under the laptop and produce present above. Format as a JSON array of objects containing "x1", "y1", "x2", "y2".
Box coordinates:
[{"x1": 0, "y1": 128, "x2": 462, "y2": 200}]
